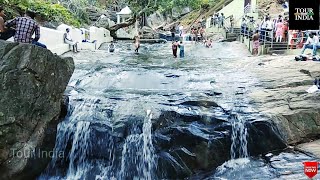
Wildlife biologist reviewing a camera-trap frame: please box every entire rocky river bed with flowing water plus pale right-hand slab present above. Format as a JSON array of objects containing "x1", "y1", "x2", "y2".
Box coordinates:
[{"x1": 39, "y1": 42, "x2": 319, "y2": 179}]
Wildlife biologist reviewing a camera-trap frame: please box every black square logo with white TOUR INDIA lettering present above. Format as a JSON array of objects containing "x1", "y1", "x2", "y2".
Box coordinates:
[{"x1": 289, "y1": 0, "x2": 320, "y2": 30}]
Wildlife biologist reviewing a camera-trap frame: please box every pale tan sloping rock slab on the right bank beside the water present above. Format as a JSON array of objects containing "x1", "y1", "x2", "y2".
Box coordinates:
[{"x1": 250, "y1": 56, "x2": 320, "y2": 144}]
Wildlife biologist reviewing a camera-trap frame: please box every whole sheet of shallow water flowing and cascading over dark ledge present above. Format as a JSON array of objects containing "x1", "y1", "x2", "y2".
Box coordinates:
[{"x1": 40, "y1": 43, "x2": 316, "y2": 180}]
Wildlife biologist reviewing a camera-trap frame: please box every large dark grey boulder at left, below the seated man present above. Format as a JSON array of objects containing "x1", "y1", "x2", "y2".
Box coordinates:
[{"x1": 0, "y1": 41, "x2": 74, "y2": 179}]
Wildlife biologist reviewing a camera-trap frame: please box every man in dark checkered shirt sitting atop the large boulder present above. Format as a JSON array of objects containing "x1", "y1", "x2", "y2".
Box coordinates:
[{"x1": 5, "y1": 11, "x2": 47, "y2": 48}]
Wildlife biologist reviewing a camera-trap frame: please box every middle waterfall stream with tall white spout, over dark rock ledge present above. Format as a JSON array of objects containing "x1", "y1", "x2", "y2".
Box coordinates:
[{"x1": 120, "y1": 110, "x2": 156, "y2": 180}]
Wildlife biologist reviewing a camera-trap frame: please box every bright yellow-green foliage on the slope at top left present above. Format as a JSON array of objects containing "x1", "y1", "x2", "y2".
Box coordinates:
[{"x1": 0, "y1": 0, "x2": 80, "y2": 27}]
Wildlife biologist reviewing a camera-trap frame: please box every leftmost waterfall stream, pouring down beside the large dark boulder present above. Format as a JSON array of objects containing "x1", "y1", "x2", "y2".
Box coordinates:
[{"x1": 39, "y1": 99, "x2": 97, "y2": 179}]
